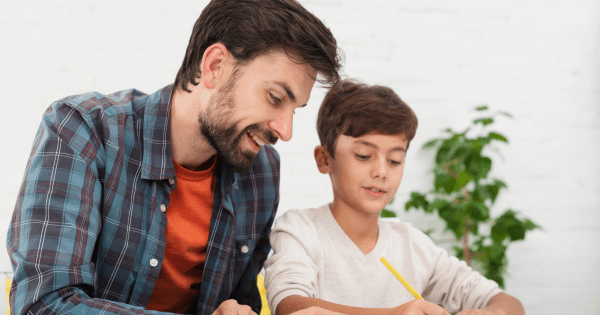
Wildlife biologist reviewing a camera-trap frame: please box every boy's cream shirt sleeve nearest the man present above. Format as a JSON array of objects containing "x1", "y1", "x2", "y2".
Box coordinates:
[{"x1": 265, "y1": 210, "x2": 321, "y2": 313}]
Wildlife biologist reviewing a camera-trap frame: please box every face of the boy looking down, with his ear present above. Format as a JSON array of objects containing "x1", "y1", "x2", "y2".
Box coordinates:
[{"x1": 315, "y1": 133, "x2": 407, "y2": 214}]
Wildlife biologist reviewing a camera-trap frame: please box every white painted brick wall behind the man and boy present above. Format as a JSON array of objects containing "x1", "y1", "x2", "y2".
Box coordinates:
[{"x1": 0, "y1": 0, "x2": 600, "y2": 315}]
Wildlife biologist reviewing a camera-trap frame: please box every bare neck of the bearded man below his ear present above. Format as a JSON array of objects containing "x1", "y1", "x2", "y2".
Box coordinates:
[{"x1": 169, "y1": 84, "x2": 217, "y2": 171}]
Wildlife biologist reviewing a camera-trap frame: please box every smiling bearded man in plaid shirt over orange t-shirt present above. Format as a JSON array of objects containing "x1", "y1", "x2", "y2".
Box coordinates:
[{"x1": 7, "y1": 0, "x2": 340, "y2": 314}]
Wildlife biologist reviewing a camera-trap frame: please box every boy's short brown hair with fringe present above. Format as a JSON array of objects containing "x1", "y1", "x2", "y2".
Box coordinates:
[{"x1": 317, "y1": 79, "x2": 418, "y2": 157}]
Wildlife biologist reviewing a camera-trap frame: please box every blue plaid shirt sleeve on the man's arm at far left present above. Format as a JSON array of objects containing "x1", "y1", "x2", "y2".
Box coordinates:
[{"x1": 7, "y1": 102, "x2": 171, "y2": 314}]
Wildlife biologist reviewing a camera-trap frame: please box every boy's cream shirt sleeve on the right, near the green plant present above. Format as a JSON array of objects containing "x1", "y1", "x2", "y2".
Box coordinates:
[{"x1": 412, "y1": 228, "x2": 502, "y2": 313}]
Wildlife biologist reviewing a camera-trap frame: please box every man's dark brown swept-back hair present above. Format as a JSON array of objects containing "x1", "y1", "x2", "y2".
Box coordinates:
[{"x1": 175, "y1": 0, "x2": 340, "y2": 92}]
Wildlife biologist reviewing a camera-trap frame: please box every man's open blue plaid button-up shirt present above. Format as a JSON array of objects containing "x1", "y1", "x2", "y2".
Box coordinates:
[{"x1": 7, "y1": 86, "x2": 279, "y2": 314}]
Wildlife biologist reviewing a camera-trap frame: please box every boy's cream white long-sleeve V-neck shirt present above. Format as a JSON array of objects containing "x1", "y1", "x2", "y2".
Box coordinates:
[{"x1": 265, "y1": 205, "x2": 502, "y2": 312}]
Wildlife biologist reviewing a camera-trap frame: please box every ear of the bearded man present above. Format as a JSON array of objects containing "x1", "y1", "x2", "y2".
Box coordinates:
[{"x1": 200, "y1": 43, "x2": 232, "y2": 89}]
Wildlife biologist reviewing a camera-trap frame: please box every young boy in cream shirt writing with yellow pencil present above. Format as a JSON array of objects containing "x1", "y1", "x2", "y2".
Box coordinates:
[{"x1": 265, "y1": 80, "x2": 524, "y2": 315}]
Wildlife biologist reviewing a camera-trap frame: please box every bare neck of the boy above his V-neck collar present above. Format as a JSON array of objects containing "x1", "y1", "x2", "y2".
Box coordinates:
[{"x1": 329, "y1": 202, "x2": 379, "y2": 255}]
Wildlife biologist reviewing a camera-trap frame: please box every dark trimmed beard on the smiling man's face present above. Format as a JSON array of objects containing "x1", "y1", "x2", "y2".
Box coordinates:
[{"x1": 198, "y1": 73, "x2": 277, "y2": 173}]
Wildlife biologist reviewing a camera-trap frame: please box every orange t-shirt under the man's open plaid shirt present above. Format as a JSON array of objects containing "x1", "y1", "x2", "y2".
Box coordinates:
[{"x1": 146, "y1": 156, "x2": 217, "y2": 314}]
